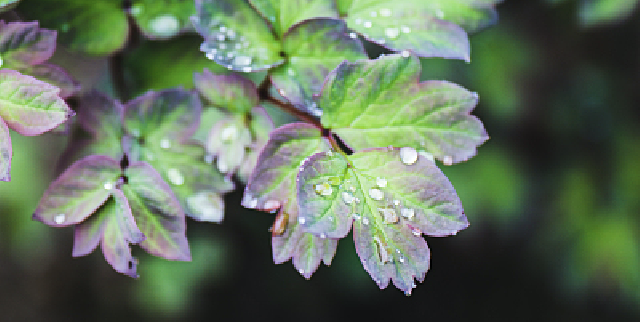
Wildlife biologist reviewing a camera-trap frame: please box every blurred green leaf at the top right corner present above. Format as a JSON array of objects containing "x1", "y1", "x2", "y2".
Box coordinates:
[{"x1": 578, "y1": 0, "x2": 638, "y2": 27}]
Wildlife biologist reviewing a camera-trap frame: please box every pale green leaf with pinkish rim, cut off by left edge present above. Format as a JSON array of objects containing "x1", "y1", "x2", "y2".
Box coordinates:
[{"x1": 0, "y1": 69, "x2": 74, "y2": 136}]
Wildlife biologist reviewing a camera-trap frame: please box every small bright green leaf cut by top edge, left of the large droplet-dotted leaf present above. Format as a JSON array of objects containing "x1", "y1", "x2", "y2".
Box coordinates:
[{"x1": 249, "y1": 0, "x2": 338, "y2": 36}]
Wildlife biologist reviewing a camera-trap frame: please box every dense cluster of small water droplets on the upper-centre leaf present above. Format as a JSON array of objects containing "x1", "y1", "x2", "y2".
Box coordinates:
[{"x1": 191, "y1": 17, "x2": 274, "y2": 73}]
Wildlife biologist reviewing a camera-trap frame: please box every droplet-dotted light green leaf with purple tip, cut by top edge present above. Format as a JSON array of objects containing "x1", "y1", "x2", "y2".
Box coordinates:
[{"x1": 340, "y1": 0, "x2": 470, "y2": 61}]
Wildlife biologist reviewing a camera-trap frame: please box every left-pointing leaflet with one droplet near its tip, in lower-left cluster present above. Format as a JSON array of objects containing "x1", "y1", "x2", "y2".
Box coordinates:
[{"x1": 33, "y1": 155, "x2": 120, "y2": 226}]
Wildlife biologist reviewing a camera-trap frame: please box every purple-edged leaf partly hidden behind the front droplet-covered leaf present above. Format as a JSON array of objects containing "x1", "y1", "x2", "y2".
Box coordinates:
[{"x1": 242, "y1": 123, "x2": 338, "y2": 278}]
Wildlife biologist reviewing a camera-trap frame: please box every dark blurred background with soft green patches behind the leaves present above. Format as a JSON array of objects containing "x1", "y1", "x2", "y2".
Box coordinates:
[{"x1": 0, "y1": 0, "x2": 640, "y2": 321}]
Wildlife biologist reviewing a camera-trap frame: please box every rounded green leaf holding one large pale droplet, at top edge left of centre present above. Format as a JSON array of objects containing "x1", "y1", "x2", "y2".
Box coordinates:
[{"x1": 129, "y1": 0, "x2": 196, "y2": 39}]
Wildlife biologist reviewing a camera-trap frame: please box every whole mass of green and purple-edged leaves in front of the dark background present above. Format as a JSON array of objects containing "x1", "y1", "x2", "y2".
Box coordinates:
[{"x1": 0, "y1": 0, "x2": 498, "y2": 294}]
